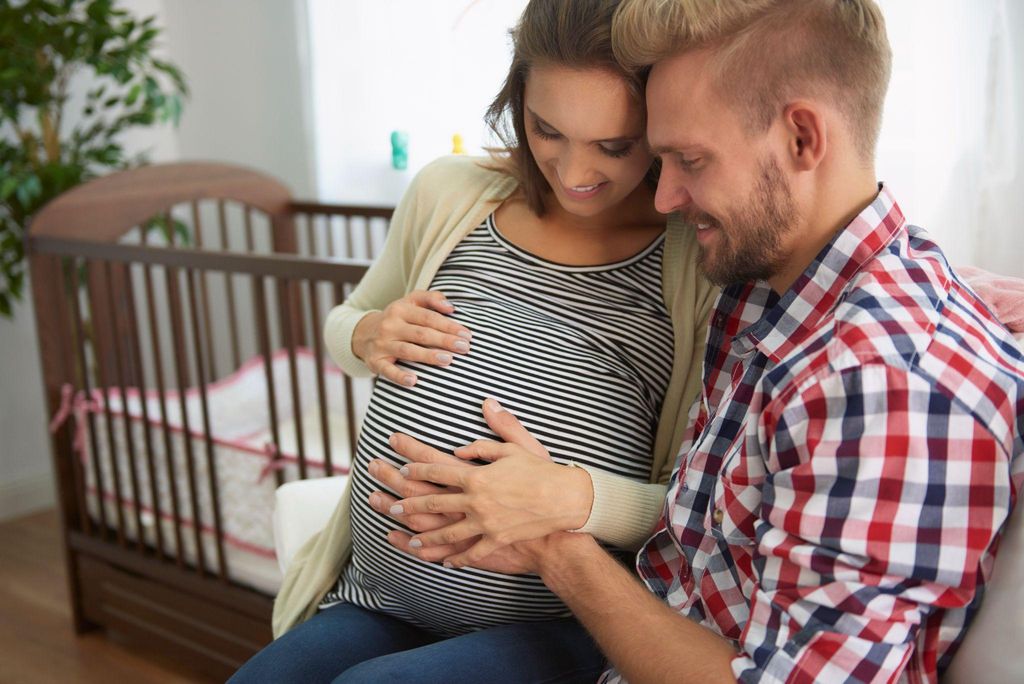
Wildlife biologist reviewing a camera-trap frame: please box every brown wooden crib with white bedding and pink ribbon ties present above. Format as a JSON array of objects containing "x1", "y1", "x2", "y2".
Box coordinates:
[{"x1": 27, "y1": 163, "x2": 391, "y2": 679}]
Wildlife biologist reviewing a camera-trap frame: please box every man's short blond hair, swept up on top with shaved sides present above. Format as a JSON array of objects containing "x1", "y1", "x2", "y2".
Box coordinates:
[{"x1": 612, "y1": 0, "x2": 892, "y2": 163}]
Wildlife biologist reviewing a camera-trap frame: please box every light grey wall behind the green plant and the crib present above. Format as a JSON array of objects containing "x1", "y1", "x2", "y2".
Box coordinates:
[{"x1": 0, "y1": 0, "x2": 315, "y2": 520}]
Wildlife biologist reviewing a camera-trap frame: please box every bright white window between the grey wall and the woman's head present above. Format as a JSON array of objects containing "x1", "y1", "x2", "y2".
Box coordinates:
[{"x1": 307, "y1": 0, "x2": 526, "y2": 205}]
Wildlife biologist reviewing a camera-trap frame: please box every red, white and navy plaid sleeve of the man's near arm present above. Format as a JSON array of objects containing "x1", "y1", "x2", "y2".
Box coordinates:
[{"x1": 733, "y1": 362, "x2": 1012, "y2": 683}]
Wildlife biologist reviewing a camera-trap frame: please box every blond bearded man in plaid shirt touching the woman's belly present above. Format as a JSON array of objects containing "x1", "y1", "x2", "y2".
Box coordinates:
[{"x1": 376, "y1": 0, "x2": 1024, "y2": 682}]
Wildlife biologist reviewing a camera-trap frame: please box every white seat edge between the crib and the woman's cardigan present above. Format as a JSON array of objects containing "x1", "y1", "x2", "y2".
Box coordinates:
[{"x1": 273, "y1": 475, "x2": 348, "y2": 574}]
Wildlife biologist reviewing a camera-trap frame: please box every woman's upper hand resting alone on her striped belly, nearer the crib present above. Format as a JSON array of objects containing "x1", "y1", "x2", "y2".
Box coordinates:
[{"x1": 352, "y1": 291, "x2": 472, "y2": 387}]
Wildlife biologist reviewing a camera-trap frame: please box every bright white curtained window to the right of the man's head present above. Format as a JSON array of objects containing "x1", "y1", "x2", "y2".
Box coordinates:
[{"x1": 878, "y1": 0, "x2": 1024, "y2": 275}]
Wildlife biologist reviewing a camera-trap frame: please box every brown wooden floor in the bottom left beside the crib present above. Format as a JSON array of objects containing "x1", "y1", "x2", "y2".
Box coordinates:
[{"x1": 0, "y1": 510, "x2": 218, "y2": 684}]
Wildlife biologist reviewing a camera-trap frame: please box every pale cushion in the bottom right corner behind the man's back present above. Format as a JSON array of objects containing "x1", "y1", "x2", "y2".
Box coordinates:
[{"x1": 943, "y1": 493, "x2": 1024, "y2": 684}]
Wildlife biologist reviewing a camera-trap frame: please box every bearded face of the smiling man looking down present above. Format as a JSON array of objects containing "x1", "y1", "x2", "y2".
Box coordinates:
[{"x1": 647, "y1": 52, "x2": 798, "y2": 285}]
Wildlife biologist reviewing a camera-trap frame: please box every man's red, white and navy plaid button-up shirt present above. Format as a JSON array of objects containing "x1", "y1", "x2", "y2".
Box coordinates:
[{"x1": 604, "y1": 187, "x2": 1024, "y2": 682}]
